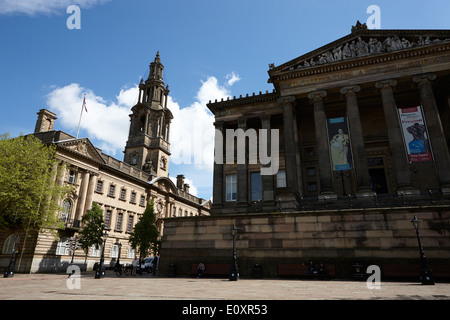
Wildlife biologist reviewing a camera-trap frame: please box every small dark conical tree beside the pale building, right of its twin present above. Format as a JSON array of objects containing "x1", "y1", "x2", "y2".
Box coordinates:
[{"x1": 129, "y1": 200, "x2": 159, "y2": 259}]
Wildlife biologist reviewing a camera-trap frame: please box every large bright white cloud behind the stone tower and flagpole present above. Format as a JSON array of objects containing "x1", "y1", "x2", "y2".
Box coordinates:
[{"x1": 47, "y1": 76, "x2": 231, "y2": 197}]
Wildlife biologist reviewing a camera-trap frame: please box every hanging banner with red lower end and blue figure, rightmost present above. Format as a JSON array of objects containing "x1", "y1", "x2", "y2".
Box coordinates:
[{"x1": 398, "y1": 106, "x2": 433, "y2": 162}]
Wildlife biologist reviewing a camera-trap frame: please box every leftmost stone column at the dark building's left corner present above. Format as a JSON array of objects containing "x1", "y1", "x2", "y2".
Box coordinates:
[{"x1": 212, "y1": 122, "x2": 225, "y2": 209}]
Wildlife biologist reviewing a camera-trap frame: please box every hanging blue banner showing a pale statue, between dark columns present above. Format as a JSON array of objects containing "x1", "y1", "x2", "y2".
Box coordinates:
[{"x1": 328, "y1": 117, "x2": 352, "y2": 171}]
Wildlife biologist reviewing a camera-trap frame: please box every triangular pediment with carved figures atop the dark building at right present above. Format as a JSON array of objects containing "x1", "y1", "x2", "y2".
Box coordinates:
[{"x1": 269, "y1": 27, "x2": 450, "y2": 77}]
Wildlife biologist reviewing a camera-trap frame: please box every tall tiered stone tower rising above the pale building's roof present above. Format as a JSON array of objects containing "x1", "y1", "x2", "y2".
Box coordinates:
[{"x1": 124, "y1": 51, "x2": 173, "y2": 177}]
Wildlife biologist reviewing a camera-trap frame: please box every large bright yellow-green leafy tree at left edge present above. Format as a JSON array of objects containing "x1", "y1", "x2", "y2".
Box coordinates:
[{"x1": 0, "y1": 134, "x2": 72, "y2": 266}]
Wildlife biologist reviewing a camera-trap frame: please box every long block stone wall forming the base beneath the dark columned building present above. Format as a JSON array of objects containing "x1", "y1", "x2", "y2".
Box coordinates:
[{"x1": 159, "y1": 206, "x2": 450, "y2": 278}]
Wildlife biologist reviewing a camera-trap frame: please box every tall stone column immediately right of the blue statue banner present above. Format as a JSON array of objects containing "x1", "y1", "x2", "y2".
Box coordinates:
[{"x1": 341, "y1": 86, "x2": 373, "y2": 196}]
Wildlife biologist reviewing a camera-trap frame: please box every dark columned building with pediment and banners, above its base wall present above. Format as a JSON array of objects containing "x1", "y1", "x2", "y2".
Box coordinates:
[{"x1": 208, "y1": 23, "x2": 450, "y2": 214}]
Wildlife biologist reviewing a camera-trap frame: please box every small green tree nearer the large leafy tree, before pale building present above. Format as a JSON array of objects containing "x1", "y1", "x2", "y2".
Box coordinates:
[{"x1": 78, "y1": 202, "x2": 105, "y2": 268}]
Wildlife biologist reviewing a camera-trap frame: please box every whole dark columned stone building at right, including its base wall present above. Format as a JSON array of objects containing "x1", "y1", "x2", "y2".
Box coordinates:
[{"x1": 161, "y1": 24, "x2": 450, "y2": 277}]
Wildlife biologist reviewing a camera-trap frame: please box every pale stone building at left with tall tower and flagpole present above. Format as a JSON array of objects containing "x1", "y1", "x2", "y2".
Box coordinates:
[{"x1": 0, "y1": 53, "x2": 210, "y2": 272}]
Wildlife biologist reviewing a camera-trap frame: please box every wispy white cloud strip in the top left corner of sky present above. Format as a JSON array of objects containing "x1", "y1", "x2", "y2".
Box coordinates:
[{"x1": 0, "y1": 0, "x2": 110, "y2": 16}]
